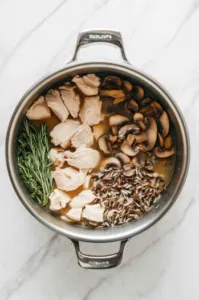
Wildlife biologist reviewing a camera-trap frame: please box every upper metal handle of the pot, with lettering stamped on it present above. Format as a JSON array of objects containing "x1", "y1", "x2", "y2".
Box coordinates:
[{"x1": 72, "y1": 30, "x2": 129, "y2": 63}]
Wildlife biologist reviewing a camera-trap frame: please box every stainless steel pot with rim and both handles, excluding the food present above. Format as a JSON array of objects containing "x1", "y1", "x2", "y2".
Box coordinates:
[{"x1": 6, "y1": 30, "x2": 189, "y2": 269}]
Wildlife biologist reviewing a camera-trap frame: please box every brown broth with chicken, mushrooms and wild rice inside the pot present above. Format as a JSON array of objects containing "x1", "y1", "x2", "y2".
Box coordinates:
[{"x1": 18, "y1": 74, "x2": 175, "y2": 227}]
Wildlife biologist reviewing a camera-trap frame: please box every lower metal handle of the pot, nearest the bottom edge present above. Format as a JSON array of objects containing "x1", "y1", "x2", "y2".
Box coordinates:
[{"x1": 72, "y1": 239, "x2": 128, "y2": 269}]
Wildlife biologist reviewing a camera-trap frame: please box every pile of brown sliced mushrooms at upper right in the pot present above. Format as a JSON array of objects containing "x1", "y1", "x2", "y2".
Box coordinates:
[{"x1": 98, "y1": 75, "x2": 175, "y2": 162}]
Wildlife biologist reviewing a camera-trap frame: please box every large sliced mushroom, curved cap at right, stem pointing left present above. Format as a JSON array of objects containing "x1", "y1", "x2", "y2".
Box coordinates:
[{"x1": 135, "y1": 117, "x2": 157, "y2": 151}]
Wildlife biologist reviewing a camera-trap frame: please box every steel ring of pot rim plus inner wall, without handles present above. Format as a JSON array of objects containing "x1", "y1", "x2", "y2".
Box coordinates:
[{"x1": 6, "y1": 62, "x2": 189, "y2": 242}]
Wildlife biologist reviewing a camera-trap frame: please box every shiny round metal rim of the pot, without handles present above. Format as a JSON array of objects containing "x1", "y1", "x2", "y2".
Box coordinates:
[{"x1": 5, "y1": 59, "x2": 190, "y2": 243}]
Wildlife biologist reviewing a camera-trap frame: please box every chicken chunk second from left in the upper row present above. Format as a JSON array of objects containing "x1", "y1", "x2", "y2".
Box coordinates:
[{"x1": 45, "y1": 90, "x2": 69, "y2": 122}]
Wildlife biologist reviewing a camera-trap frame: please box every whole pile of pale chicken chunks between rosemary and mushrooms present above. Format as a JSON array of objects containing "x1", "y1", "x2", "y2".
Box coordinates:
[{"x1": 27, "y1": 74, "x2": 104, "y2": 222}]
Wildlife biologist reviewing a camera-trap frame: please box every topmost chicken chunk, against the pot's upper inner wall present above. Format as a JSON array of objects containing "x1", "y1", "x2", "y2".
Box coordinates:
[{"x1": 72, "y1": 74, "x2": 100, "y2": 96}]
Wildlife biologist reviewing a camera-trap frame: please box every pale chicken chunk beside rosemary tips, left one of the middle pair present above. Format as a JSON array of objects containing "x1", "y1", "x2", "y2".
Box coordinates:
[{"x1": 50, "y1": 120, "x2": 80, "y2": 149}]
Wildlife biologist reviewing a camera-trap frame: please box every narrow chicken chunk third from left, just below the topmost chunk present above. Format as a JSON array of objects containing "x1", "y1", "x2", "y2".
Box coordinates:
[{"x1": 59, "y1": 84, "x2": 80, "y2": 118}]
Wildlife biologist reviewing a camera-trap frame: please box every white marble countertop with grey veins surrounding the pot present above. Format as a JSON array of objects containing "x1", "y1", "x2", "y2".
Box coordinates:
[{"x1": 0, "y1": 0, "x2": 199, "y2": 300}]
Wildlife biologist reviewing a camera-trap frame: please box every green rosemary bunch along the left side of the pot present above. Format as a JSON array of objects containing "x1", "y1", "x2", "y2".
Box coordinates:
[{"x1": 18, "y1": 119, "x2": 53, "y2": 206}]
